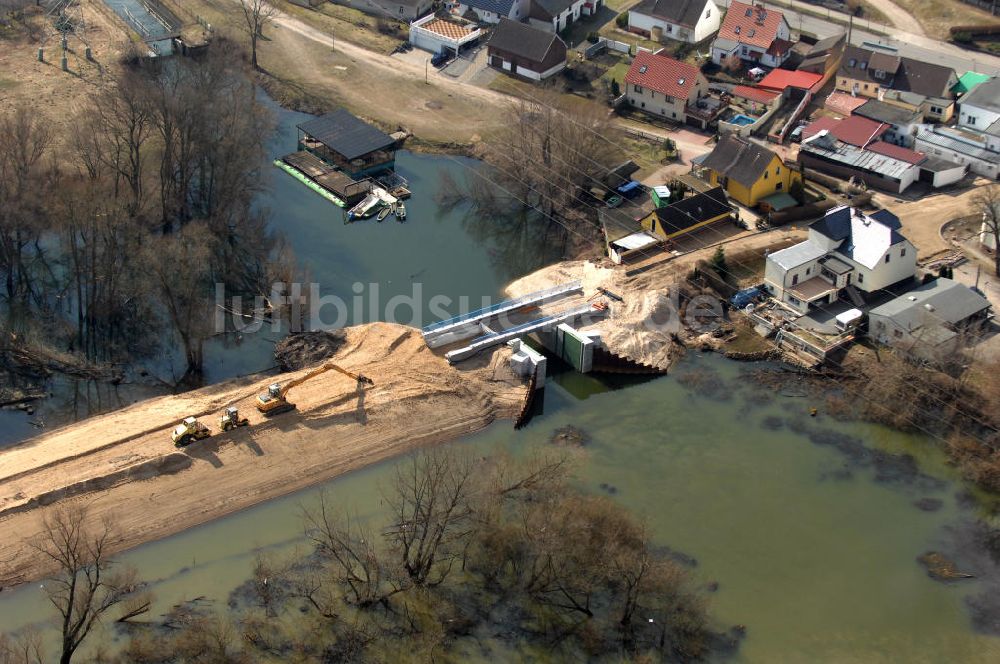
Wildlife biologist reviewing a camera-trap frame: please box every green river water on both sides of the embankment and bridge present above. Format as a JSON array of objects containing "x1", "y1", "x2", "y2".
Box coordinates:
[{"x1": 0, "y1": 100, "x2": 1000, "y2": 662}]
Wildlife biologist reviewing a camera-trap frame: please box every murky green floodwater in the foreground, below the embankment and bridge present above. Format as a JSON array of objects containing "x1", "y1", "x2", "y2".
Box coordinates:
[{"x1": 0, "y1": 355, "x2": 1000, "y2": 662}]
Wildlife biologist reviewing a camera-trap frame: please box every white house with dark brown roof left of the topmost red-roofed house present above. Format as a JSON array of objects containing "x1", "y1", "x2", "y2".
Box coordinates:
[{"x1": 628, "y1": 0, "x2": 722, "y2": 44}]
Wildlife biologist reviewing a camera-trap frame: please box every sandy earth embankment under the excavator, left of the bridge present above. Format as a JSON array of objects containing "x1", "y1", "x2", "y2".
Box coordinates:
[{"x1": 0, "y1": 323, "x2": 526, "y2": 587}]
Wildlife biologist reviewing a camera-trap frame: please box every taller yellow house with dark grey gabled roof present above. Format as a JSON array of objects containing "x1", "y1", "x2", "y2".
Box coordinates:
[{"x1": 698, "y1": 134, "x2": 802, "y2": 208}]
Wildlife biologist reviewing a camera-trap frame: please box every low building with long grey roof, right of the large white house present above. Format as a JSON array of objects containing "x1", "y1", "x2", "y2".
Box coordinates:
[{"x1": 868, "y1": 278, "x2": 990, "y2": 361}]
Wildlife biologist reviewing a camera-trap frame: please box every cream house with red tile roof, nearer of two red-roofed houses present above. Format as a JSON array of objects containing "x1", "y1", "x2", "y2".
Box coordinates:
[{"x1": 625, "y1": 51, "x2": 723, "y2": 129}]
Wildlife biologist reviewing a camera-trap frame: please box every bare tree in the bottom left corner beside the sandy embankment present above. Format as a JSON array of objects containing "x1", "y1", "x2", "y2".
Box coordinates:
[{"x1": 31, "y1": 507, "x2": 149, "y2": 664}]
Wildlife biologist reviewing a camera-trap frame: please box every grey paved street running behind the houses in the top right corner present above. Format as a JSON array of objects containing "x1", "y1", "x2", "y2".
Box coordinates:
[{"x1": 718, "y1": 0, "x2": 1000, "y2": 75}]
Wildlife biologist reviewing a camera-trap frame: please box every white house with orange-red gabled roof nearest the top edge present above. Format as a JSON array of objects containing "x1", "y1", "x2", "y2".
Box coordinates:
[{"x1": 712, "y1": 0, "x2": 793, "y2": 67}]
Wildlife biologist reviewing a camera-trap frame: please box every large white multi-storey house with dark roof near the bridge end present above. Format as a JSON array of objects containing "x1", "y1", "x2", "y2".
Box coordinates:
[{"x1": 764, "y1": 205, "x2": 917, "y2": 314}]
